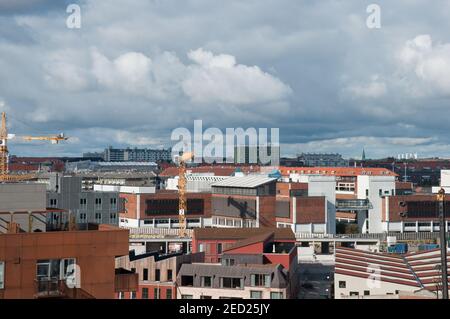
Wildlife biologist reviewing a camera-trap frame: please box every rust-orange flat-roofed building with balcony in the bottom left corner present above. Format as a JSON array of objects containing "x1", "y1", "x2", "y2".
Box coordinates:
[{"x1": 0, "y1": 225, "x2": 137, "y2": 299}]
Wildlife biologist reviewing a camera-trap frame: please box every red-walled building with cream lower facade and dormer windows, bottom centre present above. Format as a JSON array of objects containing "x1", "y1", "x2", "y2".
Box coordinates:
[{"x1": 177, "y1": 228, "x2": 298, "y2": 299}]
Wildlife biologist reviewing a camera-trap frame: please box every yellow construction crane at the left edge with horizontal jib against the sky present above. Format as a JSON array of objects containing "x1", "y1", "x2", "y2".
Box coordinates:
[{"x1": 0, "y1": 112, "x2": 68, "y2": 182}]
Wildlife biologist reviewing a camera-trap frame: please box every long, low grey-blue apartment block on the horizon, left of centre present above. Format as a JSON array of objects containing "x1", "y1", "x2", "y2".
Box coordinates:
[{"x1": 104, "y1": 147, "x2": 172, "y2": 162}]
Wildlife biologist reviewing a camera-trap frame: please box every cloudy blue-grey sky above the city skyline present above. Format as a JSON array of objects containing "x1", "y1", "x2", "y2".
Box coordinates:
[{"x1": 0, "y1": 0, "x2": 450, "y2": 158}]
